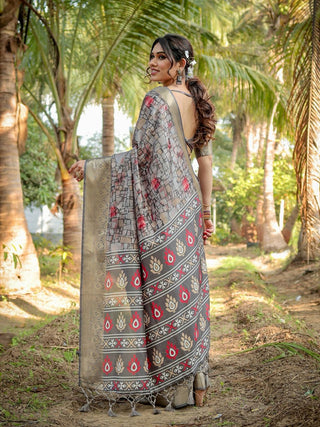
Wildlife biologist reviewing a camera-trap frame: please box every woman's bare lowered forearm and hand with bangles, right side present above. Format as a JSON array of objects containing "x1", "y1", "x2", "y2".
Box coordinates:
[{"x1": 197, "y1": 155, "x2": 213, "y2": 242}]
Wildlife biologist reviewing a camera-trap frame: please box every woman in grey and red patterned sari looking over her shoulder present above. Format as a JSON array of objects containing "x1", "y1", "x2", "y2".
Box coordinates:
[{"x1": 69, "y1": 34, "x2": 215, "y2": 415}]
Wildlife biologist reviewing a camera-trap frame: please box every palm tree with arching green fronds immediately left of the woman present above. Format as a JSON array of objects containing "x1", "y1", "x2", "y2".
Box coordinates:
[{"x1": 24, "y1": 0, "x2": 199, "y2": 268}]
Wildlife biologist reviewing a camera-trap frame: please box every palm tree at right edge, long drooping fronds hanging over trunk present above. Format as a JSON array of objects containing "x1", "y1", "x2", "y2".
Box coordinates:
[{"x1": 281, "y1": 0, "x2": 320, "y2": 261}]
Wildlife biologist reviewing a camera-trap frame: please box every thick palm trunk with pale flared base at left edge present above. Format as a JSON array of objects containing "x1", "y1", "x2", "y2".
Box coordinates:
[{"x1": 0, "y1": 0, "x2": 40, "y2": 292}]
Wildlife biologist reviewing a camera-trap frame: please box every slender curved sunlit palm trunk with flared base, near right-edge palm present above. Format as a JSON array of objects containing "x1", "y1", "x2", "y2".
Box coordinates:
[{"x1": 262, "y1": 102, "x2": 287, "y2": 252}]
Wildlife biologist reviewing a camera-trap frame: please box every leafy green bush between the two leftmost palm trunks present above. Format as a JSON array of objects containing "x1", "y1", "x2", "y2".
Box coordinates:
[{"x1": 20, "y1": 119, "x2": 58, "y2": 207}]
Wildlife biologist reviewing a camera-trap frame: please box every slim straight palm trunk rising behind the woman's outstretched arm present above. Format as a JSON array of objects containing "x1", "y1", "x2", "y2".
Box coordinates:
[{"x1": 102, "y1": 95, "x2": 115, "y2": 156}]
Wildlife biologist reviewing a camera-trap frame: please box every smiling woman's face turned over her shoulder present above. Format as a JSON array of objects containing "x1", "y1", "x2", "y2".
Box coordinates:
[{"x1": 149, "y1": 43, "x2": 179, "y2": 86}]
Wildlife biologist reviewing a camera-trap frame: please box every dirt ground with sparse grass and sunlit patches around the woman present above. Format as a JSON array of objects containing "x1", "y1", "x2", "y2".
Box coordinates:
[{"x1": 0, "y1": 245, "x2": 320, "y2": 427}]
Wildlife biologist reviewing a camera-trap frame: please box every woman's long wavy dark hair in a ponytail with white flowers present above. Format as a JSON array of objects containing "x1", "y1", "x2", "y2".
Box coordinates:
[{"x1": 147, "y1": 34, "x2": 216, "y2": 148}]
